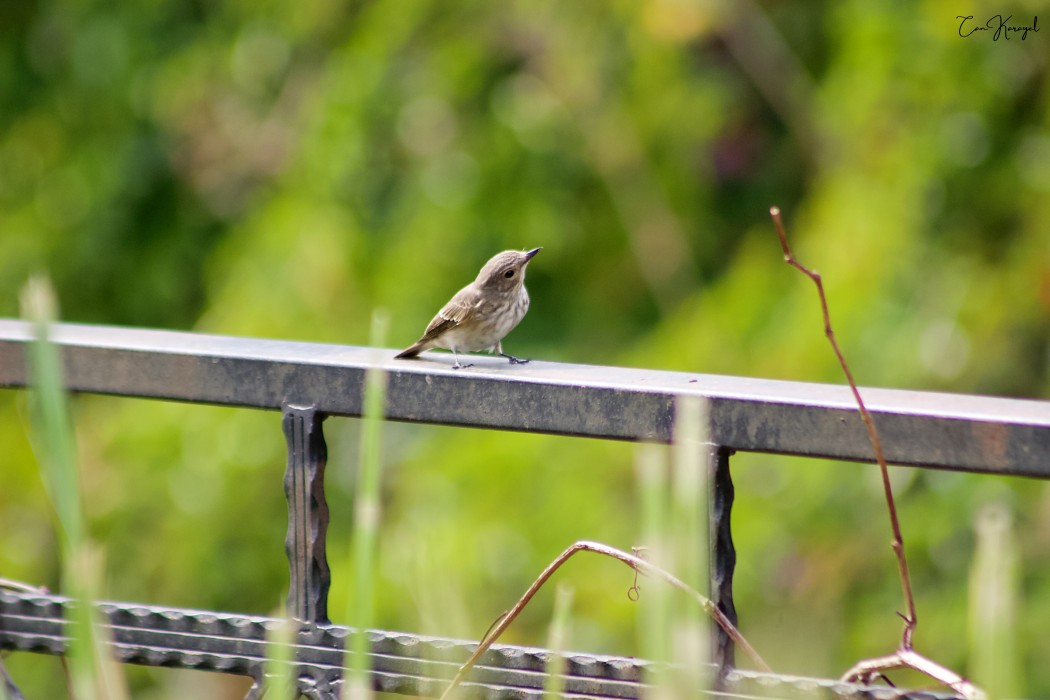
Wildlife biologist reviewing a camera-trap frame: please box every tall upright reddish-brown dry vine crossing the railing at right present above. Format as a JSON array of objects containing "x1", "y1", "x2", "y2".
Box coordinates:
[{"x1": 770, "y1": 207, "x2": 984, "y2": 698}]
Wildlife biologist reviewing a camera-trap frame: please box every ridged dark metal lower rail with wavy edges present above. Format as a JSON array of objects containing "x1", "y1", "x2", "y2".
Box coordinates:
[{"x1": 0, "y1": 590, "x2": 958, "y2": 700}]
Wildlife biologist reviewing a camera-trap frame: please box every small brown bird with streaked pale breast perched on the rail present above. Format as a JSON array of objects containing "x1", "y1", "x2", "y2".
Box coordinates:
[{"x1": 396, "y1": 248, "x2": 543, "y2": 369}]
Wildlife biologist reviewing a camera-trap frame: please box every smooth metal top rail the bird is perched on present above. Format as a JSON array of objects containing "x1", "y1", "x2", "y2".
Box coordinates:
[{"x1": 0, "y1": 319, "x2": 1050, "y2": 479}]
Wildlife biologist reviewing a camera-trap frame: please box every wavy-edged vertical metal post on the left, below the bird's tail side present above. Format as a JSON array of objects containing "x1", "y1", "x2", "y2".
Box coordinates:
[{"x1": 281, "y1": 404, "x2": 332, "y2": 623}]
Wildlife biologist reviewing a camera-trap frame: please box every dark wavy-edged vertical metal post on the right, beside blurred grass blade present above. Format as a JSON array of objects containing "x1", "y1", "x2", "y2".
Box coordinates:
[{"x1": 709, "y1": 445, "x2": 737, "y2": 672}]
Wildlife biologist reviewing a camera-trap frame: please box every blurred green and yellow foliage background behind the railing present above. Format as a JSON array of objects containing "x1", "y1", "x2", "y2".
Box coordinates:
[{"x1": 0, "y1": 0, "x2": 1050, "y2": 698}]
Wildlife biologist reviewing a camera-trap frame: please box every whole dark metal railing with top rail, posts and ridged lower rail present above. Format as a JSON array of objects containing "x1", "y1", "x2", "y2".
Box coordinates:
[{"x1": 0, "y1": 320, "x2": 1050, "y2": 698}]
